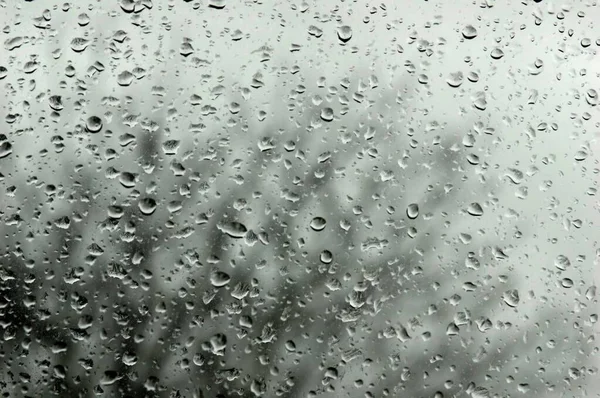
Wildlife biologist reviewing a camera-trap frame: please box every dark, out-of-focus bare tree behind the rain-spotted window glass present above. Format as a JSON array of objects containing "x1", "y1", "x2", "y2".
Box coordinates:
[{"x1": 1, "y1": 69, "x2": 591, "y2": 397}]
